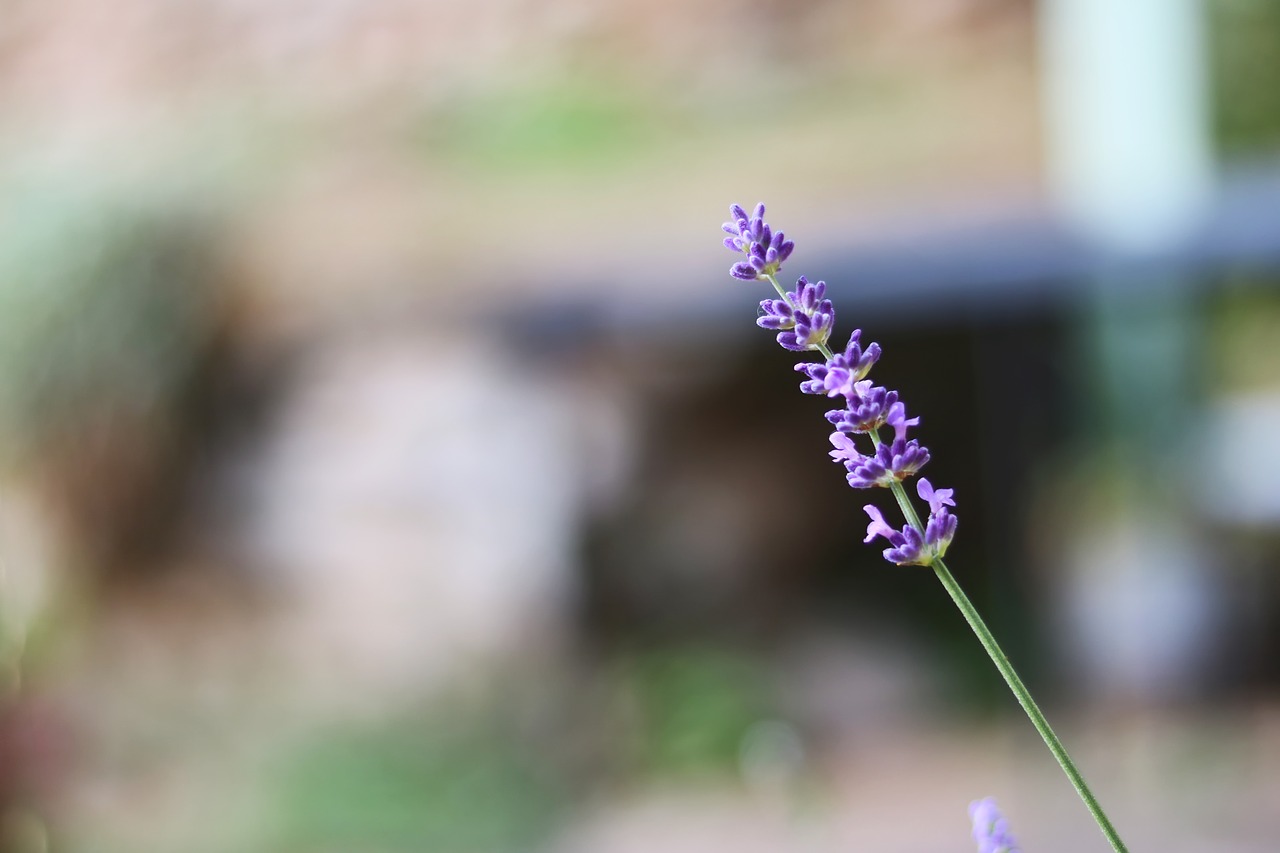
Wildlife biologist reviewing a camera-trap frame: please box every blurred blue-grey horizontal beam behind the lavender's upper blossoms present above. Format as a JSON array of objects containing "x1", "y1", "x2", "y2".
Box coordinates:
[{"x1": 506, "y1": 161, "x2": 1280, "y2": 350}]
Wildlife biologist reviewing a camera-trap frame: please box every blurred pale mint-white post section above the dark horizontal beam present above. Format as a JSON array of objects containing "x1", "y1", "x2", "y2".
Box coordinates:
[{"x1": 1039, "y1": 0, "x2": 1213, "y2": 251}]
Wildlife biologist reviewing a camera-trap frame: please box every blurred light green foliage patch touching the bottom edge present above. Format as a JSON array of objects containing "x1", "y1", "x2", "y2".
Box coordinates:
[{"x1": 265, "y1": 715, "x2": 566, "y2": 853}]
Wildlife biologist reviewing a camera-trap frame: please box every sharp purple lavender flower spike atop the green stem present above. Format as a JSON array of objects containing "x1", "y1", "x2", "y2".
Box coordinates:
[{"x1": 723, "y1": 204, "x2": 956, "y2": 566}]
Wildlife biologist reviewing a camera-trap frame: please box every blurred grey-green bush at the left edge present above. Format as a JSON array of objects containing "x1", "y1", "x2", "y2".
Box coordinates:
[{"x1": 0, "y1": 178, "x2": 216, "y2": 461}]
